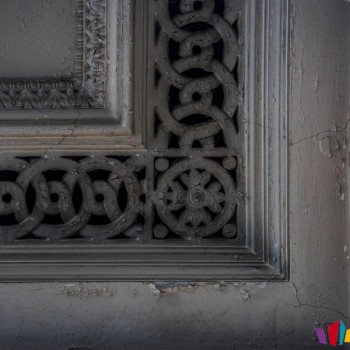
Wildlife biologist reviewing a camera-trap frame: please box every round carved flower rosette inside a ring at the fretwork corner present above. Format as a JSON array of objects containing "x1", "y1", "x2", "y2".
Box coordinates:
[{"x1": 155, "y1": 158, "x2": 239, "y2": 238}]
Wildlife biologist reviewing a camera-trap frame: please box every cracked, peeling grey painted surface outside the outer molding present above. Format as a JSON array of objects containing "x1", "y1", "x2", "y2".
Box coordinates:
[{"x1": 0, "y1": 0, "x2": 350, "y2": 349}]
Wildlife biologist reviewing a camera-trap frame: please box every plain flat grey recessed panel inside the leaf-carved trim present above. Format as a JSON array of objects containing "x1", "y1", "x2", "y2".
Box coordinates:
[{"x1": 0, "y1": 0, "x2": 77, "y2": 80}]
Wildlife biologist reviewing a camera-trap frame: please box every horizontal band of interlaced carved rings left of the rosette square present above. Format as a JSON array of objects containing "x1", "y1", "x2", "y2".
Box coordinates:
[{"x1": 0, "y1": 157, "x2": 144, "y2": 240}]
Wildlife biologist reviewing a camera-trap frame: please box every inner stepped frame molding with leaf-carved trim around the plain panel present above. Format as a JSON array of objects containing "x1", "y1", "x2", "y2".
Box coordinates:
[{"x1": 0, "y1": 0, "x2": 145, "y2": 150}]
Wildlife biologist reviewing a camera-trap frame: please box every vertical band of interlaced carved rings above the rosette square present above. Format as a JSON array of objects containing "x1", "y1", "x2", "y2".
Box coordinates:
[{"x1": 155, "y1": 0, "x2": 242, "y2": 150}]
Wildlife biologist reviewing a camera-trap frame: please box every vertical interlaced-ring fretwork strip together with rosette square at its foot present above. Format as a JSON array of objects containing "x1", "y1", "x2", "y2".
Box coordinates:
[{"x1": 153, "y1": 0, "x2": 243, "y2": 238}]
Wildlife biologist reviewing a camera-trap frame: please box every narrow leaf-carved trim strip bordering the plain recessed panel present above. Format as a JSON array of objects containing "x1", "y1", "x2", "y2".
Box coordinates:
[{"x1": 0, "y1": 0, "x2": 106, "y2": 109}]
